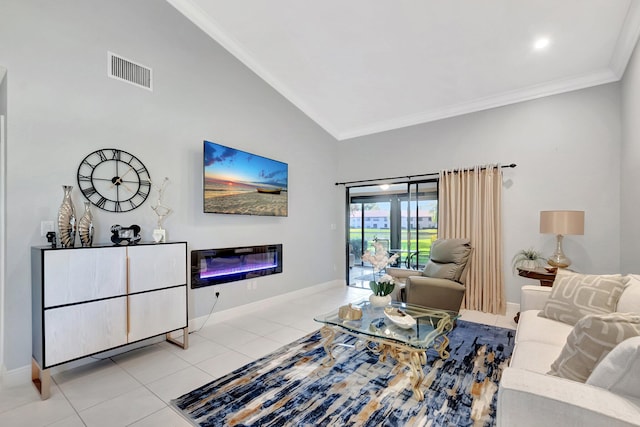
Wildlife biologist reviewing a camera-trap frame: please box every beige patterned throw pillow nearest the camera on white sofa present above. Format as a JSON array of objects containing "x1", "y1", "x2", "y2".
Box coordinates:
[{"x1": 549, "y1": 313, "x2": 640, "y2": 382}]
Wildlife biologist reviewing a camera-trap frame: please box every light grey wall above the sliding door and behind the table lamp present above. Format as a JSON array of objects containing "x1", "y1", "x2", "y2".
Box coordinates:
[{"x1": 339, "y1": 84, "x2": 620, "y2": 302}]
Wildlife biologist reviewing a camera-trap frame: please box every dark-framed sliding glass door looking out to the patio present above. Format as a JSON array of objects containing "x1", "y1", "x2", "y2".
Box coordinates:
[{"x1": 346, "y1": 180, "x2": 438, "y2": 287}]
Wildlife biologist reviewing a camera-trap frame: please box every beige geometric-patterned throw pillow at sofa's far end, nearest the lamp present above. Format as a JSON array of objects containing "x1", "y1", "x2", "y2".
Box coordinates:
[{"x1": 538, "y1": 270, "x2": 628, "y2": 325}]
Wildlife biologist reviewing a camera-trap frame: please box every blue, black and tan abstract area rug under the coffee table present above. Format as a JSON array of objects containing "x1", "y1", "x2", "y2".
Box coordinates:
[{"x1": 171, "y1": 320, "x2": 515, "y2": 427}]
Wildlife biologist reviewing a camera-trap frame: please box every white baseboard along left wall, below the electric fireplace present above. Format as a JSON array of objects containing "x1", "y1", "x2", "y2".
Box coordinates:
[{"x1": 189, "y1": 280, "x2": 346, "y2": 331}]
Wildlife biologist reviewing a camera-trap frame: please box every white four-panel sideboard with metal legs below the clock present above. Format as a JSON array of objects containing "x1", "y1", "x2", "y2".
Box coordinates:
[{"x1": 31, "y1": 242, "x2": 189, "y2": 399}]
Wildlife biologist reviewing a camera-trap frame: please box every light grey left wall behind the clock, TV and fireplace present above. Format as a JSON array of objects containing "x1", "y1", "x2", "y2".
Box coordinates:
[{"x1": 0, "y1": 0, "x2": 344, "y2": 371}]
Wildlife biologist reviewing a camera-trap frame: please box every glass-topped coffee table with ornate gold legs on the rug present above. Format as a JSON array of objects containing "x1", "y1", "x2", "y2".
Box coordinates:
[{"x1": 314, "y1": 301, "x2": 459, "y2": 401}]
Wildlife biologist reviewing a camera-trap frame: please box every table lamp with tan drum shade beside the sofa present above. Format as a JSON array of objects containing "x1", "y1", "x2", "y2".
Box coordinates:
[{"x1": 540, "y1": 211, "x2": 584, "y2": 268}]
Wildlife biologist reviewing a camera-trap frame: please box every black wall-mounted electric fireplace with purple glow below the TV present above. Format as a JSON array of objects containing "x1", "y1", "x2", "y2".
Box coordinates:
[{"x1": 191, "y1": 244, "x2": 282, "y2": 289}]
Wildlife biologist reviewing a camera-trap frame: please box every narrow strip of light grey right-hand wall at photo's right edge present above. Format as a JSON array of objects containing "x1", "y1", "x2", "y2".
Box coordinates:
[{"x1": 620, "y1": 30, "x2": 640, "y2": 273}]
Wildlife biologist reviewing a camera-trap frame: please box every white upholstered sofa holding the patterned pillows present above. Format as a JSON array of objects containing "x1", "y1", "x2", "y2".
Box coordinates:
[{"x1": 496, "y1": 276, "x2": 640, "y2": 427}]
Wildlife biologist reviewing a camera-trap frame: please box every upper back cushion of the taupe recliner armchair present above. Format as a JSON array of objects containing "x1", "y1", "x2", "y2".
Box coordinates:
[{"x1": 422, "y1": 239, "x2": 471, "y2": 282}]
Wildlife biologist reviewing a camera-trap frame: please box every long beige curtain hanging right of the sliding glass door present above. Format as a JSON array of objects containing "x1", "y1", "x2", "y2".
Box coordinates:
[{"x1": 438, "y1": 165, "x2": 506, "y2": 314}]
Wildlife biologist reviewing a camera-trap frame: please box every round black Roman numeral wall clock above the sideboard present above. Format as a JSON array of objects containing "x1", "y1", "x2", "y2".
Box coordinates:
[{"x1": 78, "y1": 148, "x2": 151, "y2": 212}]
